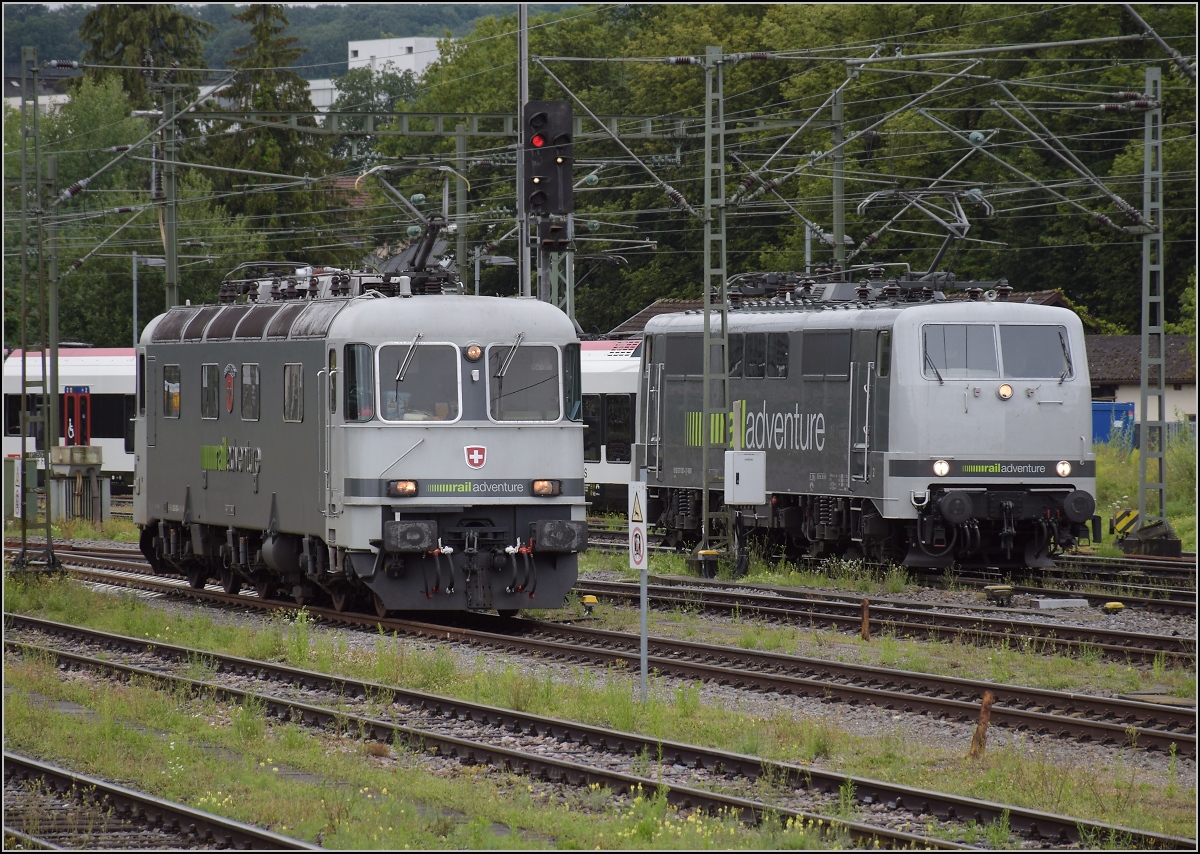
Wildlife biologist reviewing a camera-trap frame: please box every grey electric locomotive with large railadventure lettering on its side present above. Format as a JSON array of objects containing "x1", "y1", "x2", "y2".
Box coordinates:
[{"x1": 634, "y1": 276, "x2": 1099, "y2": 567}]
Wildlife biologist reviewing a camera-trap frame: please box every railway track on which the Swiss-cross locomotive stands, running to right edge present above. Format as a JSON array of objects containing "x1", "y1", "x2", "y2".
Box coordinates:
[{"x1": 4, "y1": 558, "x2": 1195, "y2": 756}]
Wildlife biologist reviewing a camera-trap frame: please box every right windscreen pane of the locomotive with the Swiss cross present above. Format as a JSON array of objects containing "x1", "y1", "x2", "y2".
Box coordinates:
[{"x1": 487, "y1": 344, "x2": 560, "y2": 421}]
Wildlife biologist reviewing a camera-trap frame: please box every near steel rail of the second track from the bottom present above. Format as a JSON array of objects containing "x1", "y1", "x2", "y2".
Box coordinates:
[{"x1": 5, "y1": 641, "x2": 964, "y2": 850}]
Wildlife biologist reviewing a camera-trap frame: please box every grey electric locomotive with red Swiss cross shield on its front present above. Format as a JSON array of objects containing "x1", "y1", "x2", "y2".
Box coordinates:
[{"x1": 134, "y1": 271, "x2": 587, "y2": 614}]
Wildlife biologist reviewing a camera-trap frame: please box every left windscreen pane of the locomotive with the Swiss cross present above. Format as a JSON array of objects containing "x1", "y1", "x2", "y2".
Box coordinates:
[{"x1": 381, "y1": 341, "x2": 460, "y2": 421}]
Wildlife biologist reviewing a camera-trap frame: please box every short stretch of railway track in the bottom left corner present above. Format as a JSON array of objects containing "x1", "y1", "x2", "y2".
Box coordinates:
[{"x1": 4, "y1": 751, "x2": 322, "y2": 850}]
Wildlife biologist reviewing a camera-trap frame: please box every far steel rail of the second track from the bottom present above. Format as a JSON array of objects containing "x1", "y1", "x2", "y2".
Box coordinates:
[{"x1": 8, "y1": 617, "x2": 1187, "y2": 848}]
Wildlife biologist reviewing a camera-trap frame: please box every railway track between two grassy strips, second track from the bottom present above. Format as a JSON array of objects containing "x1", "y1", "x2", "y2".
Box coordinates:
[{"x1": 7, "y1": 617, "x2": 1190, "y2": 848}]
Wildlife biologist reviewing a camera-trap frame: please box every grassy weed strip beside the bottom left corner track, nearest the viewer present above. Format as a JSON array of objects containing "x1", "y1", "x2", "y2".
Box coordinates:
[{"x1": 5, "y1": 657, "x2": 845, "y2": 850}]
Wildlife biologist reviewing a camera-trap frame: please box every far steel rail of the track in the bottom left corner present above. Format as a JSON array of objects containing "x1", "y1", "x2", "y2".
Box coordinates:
[{"x1": 4, "y1": 748, "x2": 324, "y2": 850}]
